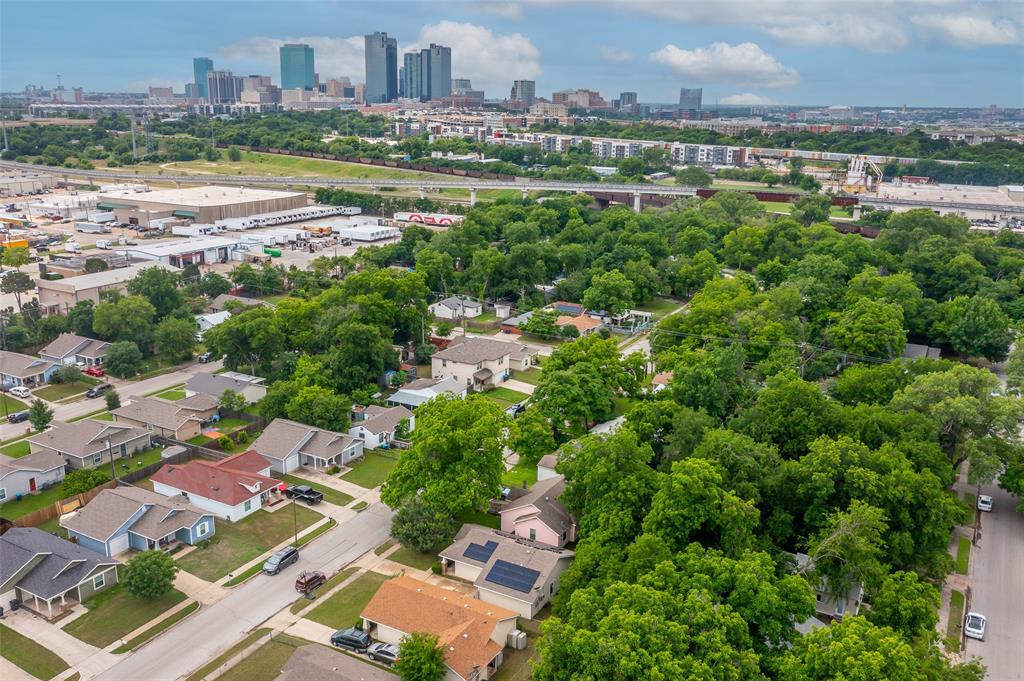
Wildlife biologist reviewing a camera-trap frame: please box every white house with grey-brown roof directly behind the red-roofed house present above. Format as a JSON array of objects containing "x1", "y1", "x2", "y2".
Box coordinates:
[{"x1": 249, "y1": 419, "x2": 362, "y2": 473}]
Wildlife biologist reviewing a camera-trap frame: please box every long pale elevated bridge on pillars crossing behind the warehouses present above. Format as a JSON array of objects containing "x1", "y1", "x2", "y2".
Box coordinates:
[{"x1": 0, "y1": 161, "x2": 697, "y2": 212}]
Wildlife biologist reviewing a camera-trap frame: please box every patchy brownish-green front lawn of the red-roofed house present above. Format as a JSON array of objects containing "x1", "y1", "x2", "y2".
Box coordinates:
[{"x1": 178, "y1": 506, "x2": 324, "y2": 582}]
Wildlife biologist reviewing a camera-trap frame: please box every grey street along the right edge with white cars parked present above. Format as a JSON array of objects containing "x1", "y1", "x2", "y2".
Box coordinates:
[{"x1": 966, "y1": 484, "x2": 1024, "y2": 681}]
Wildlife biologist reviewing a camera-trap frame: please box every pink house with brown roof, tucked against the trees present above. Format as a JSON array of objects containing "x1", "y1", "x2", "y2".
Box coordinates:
[{"x1": 501, "y1": 475, "x2": 577, "y2": 548}]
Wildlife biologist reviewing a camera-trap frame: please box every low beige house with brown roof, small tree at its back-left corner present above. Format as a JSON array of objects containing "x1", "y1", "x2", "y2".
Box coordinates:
[{"x1": 29, "y1": 419, "x2": 153, "y2": 468}]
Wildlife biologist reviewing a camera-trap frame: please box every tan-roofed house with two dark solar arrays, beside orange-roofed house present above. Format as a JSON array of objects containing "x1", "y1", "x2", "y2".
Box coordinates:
[{"x1": 439, "y1": 524, "x2": 575, "y2": 620}]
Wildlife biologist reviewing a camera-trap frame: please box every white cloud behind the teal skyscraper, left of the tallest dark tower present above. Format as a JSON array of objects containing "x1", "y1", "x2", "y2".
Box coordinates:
[{"x1": 217, "y1": 36, "x2": 366, "y2": 82}]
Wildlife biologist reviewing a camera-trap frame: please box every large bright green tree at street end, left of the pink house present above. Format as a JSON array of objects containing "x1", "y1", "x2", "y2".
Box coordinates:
[{"x1": 381, "y1": 395, "x2": 507, "y2": 516}]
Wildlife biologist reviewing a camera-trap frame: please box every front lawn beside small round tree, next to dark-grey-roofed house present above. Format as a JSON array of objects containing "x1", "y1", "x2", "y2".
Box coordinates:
[{"x1": 65, "y1": 585, "x2": 185, "y2": 648}]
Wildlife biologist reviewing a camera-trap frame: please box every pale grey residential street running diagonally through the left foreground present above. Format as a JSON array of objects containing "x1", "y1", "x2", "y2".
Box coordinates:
[{"x1": 95, "y1": 504, "x2": 391, "y2": 681}]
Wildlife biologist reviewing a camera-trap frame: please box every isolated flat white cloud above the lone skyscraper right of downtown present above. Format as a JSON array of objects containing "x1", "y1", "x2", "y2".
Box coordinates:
[{"x1": 650, "y1": 43, "x2": 800, "y2": 88}]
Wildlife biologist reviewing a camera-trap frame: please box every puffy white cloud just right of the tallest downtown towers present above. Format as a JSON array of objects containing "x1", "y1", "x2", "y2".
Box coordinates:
[{"x1": 401, "y1": 20, "x2": 541, "y2": 96}]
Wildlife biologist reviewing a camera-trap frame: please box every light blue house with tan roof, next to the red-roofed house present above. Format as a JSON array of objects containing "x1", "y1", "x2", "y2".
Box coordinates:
[{"x1": 60, "y1": 485, "x2": 217, "y2": 556}]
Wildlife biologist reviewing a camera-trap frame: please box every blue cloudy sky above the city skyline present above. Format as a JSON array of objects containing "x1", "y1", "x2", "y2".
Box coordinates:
[{"x1": 0, "y1": 0, "x2": 1024, "y2": 108}]
